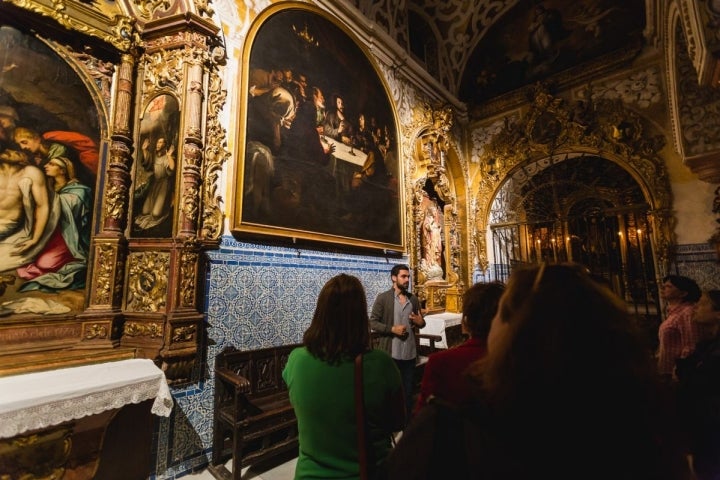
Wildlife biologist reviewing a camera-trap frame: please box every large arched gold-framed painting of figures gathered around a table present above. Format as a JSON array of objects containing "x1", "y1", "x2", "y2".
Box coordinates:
[{"x1": 232, "y1": 4, "x2": 404, "y2": 250}]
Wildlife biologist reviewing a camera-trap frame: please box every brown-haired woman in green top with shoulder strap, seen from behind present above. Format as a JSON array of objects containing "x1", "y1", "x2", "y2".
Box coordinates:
[{"x1": 283, "y1": 274, "x2": 405, "y2": 479}]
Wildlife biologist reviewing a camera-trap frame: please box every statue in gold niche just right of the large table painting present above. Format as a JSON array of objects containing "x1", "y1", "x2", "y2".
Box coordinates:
[{"x1": 419, "y1": 192, "x2": 444, "y2": 282}]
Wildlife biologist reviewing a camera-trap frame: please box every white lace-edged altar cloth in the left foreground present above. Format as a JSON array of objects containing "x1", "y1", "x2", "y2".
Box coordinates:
[{"x1": 0, "y1": 358, "x2": 173, "y2": 438}]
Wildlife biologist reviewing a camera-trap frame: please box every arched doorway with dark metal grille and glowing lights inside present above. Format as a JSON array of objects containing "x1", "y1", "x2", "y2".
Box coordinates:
[{"x1": 488, "y1": 153, "x2": 660, "y2": 338}]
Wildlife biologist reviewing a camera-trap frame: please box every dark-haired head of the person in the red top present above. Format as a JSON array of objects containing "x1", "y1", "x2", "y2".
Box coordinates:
[{"x1": 462, "y1": 282, "x2": 505, "y2": 339}]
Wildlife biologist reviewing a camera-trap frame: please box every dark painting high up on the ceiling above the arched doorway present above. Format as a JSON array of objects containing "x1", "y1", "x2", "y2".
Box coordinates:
[{"x1": 458, "y1": 0, "x2": 645, "y2": 105}]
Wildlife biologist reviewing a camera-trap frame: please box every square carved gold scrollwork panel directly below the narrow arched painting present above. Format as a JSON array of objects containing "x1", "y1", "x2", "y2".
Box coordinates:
[{"x1": 127, "y1": 252, "x2": 170, "y2": 312}]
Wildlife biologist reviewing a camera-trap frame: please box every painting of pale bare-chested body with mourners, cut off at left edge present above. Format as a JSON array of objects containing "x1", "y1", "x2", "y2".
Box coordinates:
[{"x1": 0, "y1": 26, "x2": 99, "y2": 317}]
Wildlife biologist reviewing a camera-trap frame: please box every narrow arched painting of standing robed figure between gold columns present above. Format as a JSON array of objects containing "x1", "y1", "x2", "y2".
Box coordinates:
[{"x1": 131, "y1": 94, "x2": 180, "y2": 237}]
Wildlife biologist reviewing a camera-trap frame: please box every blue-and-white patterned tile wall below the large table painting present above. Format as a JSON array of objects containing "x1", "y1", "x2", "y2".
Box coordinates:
[{"x1": 152, "y1": 237, "x2": 407, "y2": 479}]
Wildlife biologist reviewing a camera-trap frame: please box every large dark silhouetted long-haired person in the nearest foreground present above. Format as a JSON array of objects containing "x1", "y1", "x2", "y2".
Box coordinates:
[{"x1": 387, "y1": 265, "x2": 689, "y2": 480}]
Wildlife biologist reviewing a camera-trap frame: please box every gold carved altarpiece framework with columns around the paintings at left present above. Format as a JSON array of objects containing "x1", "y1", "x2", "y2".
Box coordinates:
[{"x1": 0, "y1": 0, "x2": 229, "y2": 383}]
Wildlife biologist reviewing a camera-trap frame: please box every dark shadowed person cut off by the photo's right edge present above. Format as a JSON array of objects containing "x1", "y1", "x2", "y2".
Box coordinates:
[{"x1": 677, "y1": 290, "x2": 720, "y2": 480}]
